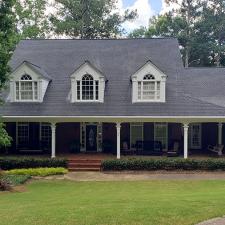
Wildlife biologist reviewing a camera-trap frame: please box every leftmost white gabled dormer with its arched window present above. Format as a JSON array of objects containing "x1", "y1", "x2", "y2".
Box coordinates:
[{"x1": 9, "y1": 61, "x2": 51, "y2": 102}]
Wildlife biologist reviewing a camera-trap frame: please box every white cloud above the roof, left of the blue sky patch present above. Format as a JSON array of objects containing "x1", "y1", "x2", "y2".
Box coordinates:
[{"x1": 117, "y1": 0, "x2": 155, "y2": 31}]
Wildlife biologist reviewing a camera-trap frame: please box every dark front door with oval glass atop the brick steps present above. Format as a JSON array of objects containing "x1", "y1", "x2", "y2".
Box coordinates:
[{"x1": 86, "y1": 125, "x2": 97, "y2": 152}]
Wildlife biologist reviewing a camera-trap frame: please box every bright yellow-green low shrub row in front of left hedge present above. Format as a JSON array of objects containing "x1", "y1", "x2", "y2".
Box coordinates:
[{"x1": 5, "y1": 167, "x2": 68, "y2": 177}]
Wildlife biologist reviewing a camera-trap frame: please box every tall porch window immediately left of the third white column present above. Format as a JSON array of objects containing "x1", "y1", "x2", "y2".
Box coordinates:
[{"x1": 154, "y1": 123, "x2": 168, "y2": 149}]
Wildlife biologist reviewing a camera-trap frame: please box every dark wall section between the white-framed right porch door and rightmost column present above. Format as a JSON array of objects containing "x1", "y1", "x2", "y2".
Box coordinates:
[{"x1": 202, "y1": 123, "x2": 218, "y2": 151}]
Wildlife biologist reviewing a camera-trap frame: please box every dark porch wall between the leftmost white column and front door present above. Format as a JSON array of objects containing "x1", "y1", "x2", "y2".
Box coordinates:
[{"x1": 56, "y1": 123, "x2": 80, "y2": 154}]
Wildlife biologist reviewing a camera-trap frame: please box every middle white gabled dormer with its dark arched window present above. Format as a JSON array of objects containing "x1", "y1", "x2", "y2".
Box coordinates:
[{"x1": 71, "y1": 61, "x2": 106, "y2": 103}]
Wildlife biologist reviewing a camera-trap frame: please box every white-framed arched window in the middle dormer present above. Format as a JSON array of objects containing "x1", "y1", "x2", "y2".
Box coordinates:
[{"x1": 77, "y1": 74, "x2": 99, "y2": 101}]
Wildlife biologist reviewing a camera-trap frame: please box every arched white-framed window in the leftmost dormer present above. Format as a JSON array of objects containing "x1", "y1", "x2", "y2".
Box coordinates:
[{"x1": 16, "y1": 74, "x2": 38, "y2": 101}]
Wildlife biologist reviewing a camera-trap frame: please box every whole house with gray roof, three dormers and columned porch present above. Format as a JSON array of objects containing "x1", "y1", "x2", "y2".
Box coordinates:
[{"x1": 0, "y1": 38, "x2": 225, "y2": 158}]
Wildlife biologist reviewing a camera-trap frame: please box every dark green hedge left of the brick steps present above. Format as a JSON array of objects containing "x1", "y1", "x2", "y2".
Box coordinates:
[{"x1": 0, "y1": 158, "x2": 67, "y2": 170}]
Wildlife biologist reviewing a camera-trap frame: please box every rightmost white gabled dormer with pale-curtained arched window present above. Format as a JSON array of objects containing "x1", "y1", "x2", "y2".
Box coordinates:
[{"x1": 131, "y1": 61, "x2": 167, "y2": 103}]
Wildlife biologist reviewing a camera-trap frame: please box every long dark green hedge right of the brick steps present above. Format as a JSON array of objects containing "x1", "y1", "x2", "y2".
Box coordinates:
[{"x1": 102, "y1": 158, "x2": 225, "y2": 171}]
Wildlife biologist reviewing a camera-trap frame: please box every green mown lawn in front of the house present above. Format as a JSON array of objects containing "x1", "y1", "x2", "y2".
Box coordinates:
[{"x1": 0, "y1": 181, "x2": 225, "y2": 225}]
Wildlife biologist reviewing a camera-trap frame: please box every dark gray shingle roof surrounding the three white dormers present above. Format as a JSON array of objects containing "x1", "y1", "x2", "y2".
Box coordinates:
[{"x1": 0, "y1": 38, "x2": 225, "y2": 116}]
